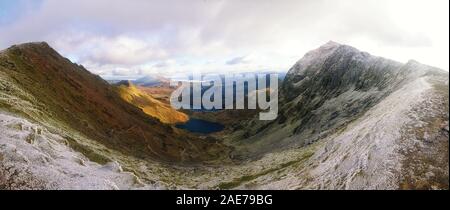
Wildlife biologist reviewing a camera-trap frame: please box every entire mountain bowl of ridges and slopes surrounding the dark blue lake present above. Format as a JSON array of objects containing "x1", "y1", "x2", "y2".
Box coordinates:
[{"x1": 0, "y1": 42, "x2": 449, "y2": 189}]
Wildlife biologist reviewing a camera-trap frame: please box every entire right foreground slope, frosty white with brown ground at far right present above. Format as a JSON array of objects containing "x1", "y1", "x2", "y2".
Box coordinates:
[{"x1": 227, "y1": 74, "x2": 449, "y2": 189}]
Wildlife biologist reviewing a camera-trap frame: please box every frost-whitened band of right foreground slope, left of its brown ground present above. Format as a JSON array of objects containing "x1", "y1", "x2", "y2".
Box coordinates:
[{"x1": 302, "y1": 78, "x2": 430, "y2": 189}]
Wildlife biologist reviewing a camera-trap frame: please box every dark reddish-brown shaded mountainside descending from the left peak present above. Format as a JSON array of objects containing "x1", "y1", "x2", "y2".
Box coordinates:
[{"x1": 0, "y1": 43, "x2": 223, "y2": 162}]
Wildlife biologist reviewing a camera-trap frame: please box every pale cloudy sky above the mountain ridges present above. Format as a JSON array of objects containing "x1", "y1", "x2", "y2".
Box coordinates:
[{"x1": 0, "y1": 0, "x2": 449, "y2": 79}]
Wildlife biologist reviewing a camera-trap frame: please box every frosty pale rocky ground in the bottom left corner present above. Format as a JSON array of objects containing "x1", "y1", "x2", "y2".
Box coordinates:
[{"x1": 0, "y1": 113, "x2": 153, "y2": 189}]
